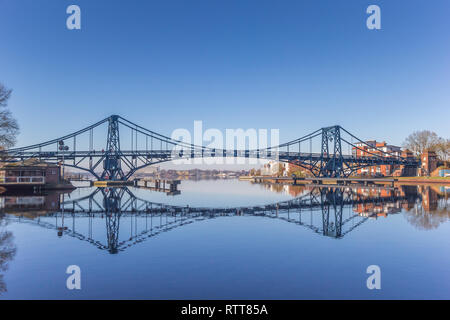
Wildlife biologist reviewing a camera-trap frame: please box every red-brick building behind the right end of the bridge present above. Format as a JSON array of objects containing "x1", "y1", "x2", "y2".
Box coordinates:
[{"x1": 352, "y1": 140, "x2": 402, "y2": 176}]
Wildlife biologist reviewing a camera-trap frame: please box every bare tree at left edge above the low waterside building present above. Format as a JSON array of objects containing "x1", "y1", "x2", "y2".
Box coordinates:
[{"x1": 0, "y1": 83, "x2": 19, "y2": 148}]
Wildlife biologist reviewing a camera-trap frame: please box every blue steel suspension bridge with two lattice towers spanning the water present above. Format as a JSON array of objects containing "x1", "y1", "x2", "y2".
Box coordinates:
[{"x1": 0, "y1": 115, "x2": 419, "y2": 181}]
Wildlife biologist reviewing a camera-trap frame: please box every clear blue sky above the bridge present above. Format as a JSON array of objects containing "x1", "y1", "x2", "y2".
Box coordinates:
[{"x1": 0, "y1": 0, "x2": 450, "y2": 145}]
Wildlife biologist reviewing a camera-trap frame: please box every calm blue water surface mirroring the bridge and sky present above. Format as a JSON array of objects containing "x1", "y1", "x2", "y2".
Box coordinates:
[{"x1": 0, "y1": 180, "x2": 450, "y2": 299}]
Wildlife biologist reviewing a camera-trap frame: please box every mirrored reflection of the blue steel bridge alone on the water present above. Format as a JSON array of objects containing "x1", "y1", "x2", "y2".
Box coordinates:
[{"x1": 3, "y1": 187, "x2": 411, "y2": 254}]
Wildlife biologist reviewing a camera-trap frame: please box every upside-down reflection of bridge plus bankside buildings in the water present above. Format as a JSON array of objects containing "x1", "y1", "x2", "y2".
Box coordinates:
[{"x1": 0, "y1": 186, "x2": 448, "y2": 254}]
